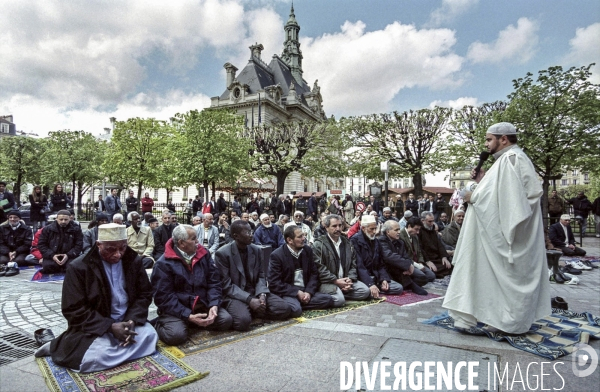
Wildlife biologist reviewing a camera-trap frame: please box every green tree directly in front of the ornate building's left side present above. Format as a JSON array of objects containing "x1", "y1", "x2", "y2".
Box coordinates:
[{"x1": 174, "y1": 110, "x2": 251, "y2": 201}]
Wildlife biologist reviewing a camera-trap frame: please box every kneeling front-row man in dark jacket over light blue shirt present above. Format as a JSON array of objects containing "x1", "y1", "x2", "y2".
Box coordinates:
[{"x1": 269, "y1": 225, "x2": 333, "y2": 317}]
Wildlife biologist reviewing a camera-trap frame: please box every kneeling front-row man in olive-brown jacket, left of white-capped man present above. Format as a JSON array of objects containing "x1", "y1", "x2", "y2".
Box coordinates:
[{"x1": 313, "y1": 214, "x2": 371, "y2": 308}]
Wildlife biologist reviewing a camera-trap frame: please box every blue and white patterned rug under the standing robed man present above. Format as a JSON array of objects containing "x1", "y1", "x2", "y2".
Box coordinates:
[{"x1": 423, "y1": 309, "x2": 600, "y2": 360}]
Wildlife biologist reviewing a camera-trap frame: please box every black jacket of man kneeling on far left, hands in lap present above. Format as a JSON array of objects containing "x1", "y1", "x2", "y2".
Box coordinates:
[{"x1": 38, "y1": 222, "x2": 83, "y2": 260}]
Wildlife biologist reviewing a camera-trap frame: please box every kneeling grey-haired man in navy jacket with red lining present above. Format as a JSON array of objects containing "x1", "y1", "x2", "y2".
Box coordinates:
[{"x1": 151, "y1": 225, "x2": 233, "y2": 346}]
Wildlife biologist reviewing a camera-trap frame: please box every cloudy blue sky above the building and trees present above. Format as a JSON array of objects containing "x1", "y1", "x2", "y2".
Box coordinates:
[{"x1": 0, "y1": 0, "x2": 600, "y2": 136}]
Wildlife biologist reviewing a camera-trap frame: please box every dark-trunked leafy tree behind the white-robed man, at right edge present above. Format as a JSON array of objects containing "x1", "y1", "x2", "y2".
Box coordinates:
[{"x1": 503, "y1": 64, "x2": 600, "y2": 216}]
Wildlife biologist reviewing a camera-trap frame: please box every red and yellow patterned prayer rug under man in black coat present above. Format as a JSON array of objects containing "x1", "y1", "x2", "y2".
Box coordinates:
[{"x1": 36, "y1": 348, "x2": 208, "y2": 392}]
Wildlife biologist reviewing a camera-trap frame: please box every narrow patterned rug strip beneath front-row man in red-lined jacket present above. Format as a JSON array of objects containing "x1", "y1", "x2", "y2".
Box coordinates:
[{"x1": 175, "y1": 318, "x2": 297, "y2": 355}]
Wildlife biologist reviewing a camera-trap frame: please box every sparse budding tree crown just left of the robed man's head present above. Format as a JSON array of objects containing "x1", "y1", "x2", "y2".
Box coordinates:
[{"x1": 448, "y1": 101, "x2": 507, "y2": 169}]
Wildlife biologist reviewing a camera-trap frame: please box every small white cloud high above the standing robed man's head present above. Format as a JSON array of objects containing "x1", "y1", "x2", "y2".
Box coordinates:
[{"x1": 467, "y1": 18, "x2": 539, "y2": 63}]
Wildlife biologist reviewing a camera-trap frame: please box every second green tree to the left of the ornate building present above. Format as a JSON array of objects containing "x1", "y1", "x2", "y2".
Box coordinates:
[{"x1": 104, "y1": 117, "x2": 175, "y2": 204}]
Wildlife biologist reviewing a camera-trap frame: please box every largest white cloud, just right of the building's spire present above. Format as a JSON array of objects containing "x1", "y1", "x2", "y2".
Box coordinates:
[{"x1": 301, "y1": 21, "x2": 464, "y2": 115}]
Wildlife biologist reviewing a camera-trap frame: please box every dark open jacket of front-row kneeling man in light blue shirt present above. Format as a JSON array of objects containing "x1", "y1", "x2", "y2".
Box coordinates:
[{"x1": 268, "y1": 245, "x2": 319, "y2": 298}]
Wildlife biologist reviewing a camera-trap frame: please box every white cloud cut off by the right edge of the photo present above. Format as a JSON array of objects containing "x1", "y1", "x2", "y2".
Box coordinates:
[{"x1": 566, "y1": 23, "x2": 600, "y2": 83}]
